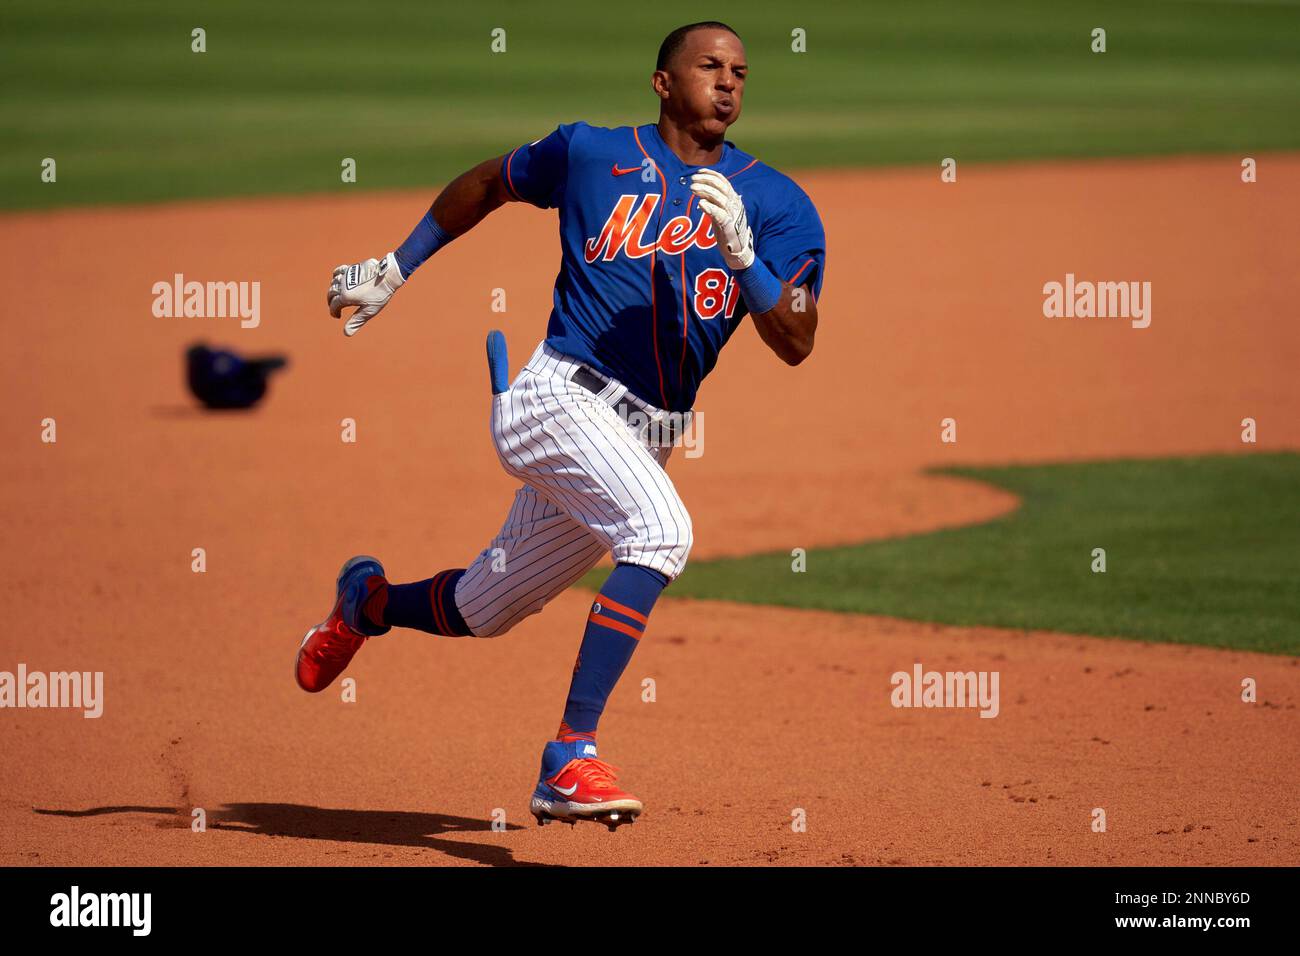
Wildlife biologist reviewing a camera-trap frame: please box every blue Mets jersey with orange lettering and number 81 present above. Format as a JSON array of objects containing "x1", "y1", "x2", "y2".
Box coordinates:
[{"x1": 502, "y1": 122, "x2": 826, "y2": 411}]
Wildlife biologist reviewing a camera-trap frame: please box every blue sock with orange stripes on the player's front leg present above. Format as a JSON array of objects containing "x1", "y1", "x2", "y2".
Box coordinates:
[{"x1": 556, "y1": 564, "x2": 668, "y2": 740}]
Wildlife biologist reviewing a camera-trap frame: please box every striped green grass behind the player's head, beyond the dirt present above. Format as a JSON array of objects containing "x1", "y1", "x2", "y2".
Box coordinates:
[{"x1": 0, "y1": 0, "x2": 1300, "y2": 208}]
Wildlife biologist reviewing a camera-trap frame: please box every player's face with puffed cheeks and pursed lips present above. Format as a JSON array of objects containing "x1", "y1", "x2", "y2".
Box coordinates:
[{"x1": 664, "y1": 30, "x2": 749, "y2": 137}]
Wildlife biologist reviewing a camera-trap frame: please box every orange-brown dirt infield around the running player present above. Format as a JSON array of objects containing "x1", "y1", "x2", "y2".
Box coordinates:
[{"x1": 0, "y1": 156, "x2": 1300, "y2": 865}]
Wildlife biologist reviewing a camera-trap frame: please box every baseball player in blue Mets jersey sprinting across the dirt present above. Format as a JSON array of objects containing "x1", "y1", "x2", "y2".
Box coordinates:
[{"x1": 296, "y1": 21, "x2": 826, "y2": 830}]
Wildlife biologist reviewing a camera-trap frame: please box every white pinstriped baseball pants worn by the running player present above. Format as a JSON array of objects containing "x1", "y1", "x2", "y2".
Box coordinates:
[{"x1": 455, "y1": 342, "x2": 692, "y2": 637}]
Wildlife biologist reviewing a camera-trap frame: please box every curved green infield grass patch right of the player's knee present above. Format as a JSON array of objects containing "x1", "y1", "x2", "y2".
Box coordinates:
[{"x1": 595, "y1": 454, "x2": 1300, "y2": 654}]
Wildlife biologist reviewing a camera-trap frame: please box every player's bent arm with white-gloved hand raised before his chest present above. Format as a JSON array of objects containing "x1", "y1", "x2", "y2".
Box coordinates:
[{"x1": 690, "y1": 169, "x2": 816, "y2": 365}]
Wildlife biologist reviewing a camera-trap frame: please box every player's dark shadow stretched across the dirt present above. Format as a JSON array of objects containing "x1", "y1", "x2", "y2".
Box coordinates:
[{"x1": 33, "y1": 804, "x2": 542, "y2": 866}]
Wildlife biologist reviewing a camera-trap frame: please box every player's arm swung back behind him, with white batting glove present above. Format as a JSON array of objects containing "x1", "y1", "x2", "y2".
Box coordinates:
[{"x1": 329, "y1": 156, "x2": 527, "y2": 336}]
